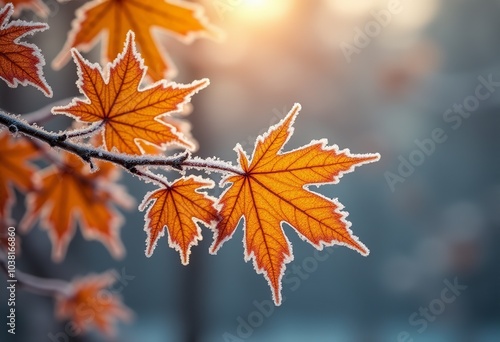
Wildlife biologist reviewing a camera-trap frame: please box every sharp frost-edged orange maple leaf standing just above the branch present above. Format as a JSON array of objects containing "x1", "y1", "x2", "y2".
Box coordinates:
[{"x1": 52, "y1": 31, "x2": 209, "y2": 154}]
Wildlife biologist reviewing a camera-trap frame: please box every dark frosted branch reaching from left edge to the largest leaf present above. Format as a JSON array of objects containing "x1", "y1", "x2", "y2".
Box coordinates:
[{"x1": 0, "y1": 111, "x2": 243, "y2": 180}]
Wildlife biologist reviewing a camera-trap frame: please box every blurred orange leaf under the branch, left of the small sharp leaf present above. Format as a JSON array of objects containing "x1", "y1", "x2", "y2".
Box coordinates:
[{"x1": 20, "y1": 153, "x2": 134, "y2": 261}]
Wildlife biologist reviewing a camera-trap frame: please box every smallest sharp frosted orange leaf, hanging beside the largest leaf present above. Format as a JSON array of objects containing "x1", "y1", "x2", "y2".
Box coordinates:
[{"x1": 139, "y1": 176, "x2": 218, "y2": 265}]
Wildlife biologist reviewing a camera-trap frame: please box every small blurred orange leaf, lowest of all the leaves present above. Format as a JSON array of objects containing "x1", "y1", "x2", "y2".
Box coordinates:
[{"x1": 56, "y1": 272, "x2": 133, "y2": 335}]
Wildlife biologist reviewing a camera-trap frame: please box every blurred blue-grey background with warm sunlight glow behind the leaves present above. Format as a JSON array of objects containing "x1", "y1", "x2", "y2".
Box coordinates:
[{"x1": 0, "y1": 0, "x2": 500, "y2": 342}]
